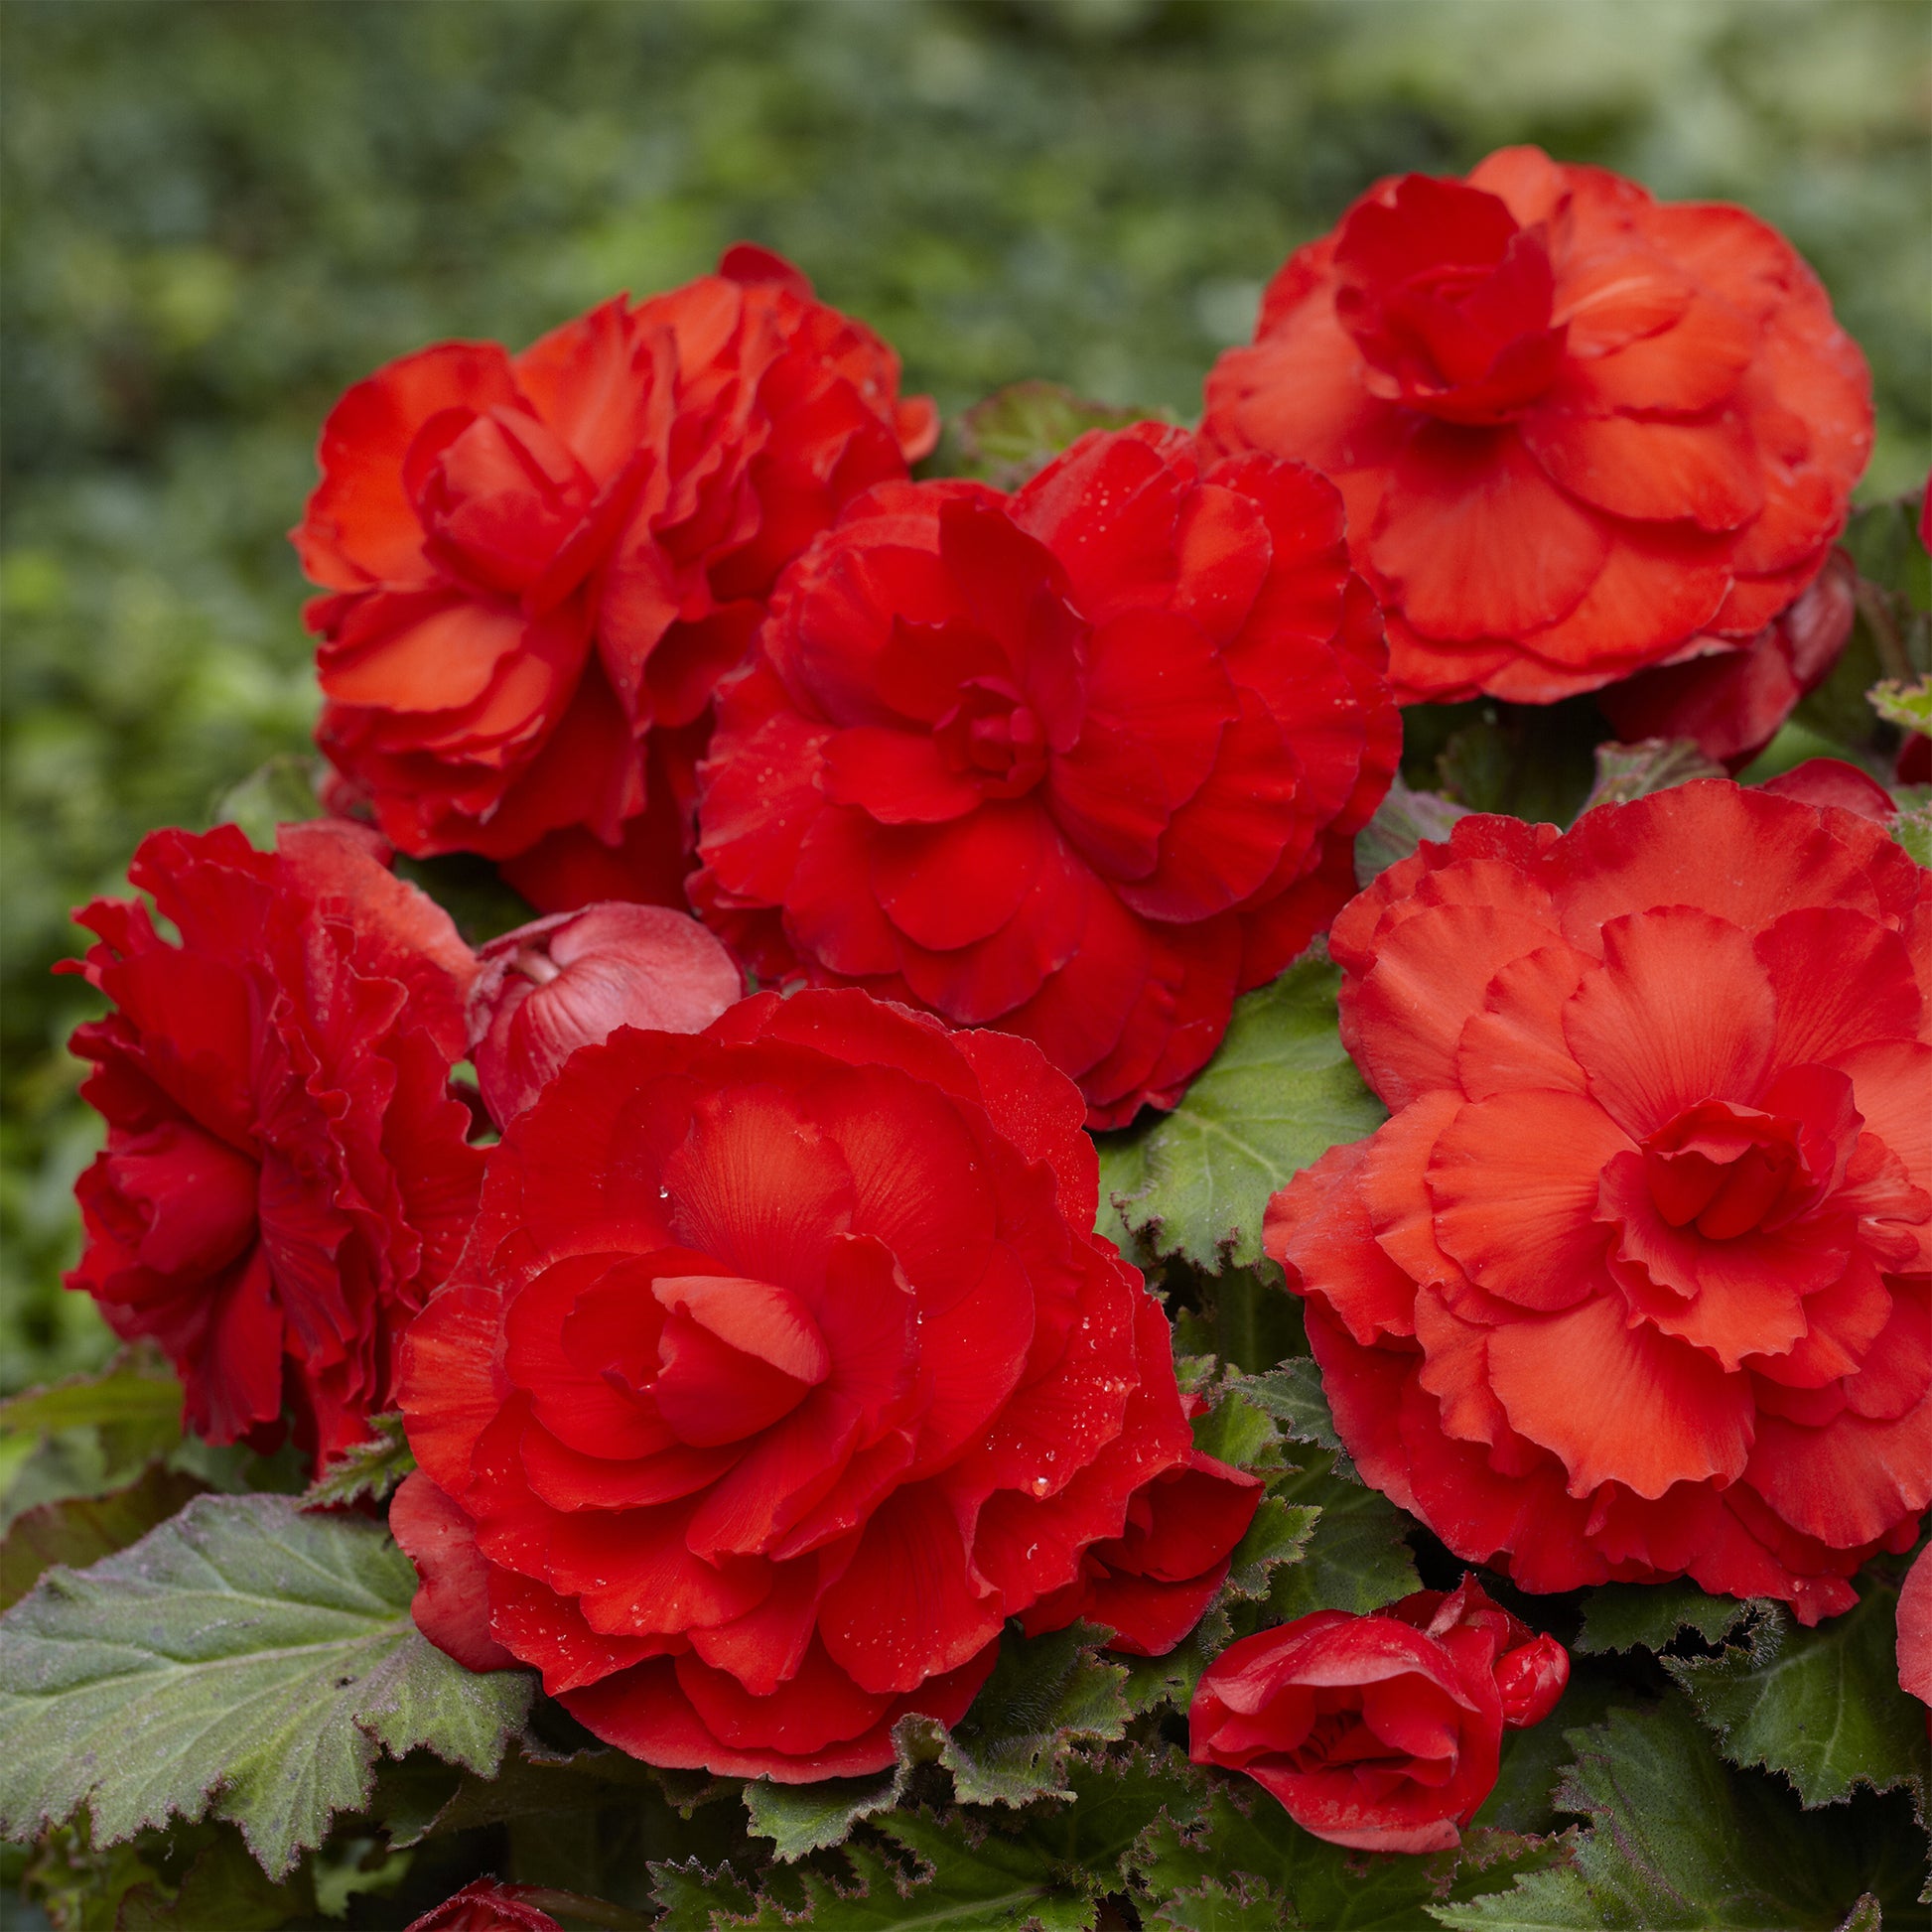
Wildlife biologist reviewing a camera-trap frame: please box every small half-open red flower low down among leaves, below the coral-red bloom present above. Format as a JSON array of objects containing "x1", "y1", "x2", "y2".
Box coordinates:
[{"x1": 1188, "y1": 1577, "x2": 1569, "y2": 1851}]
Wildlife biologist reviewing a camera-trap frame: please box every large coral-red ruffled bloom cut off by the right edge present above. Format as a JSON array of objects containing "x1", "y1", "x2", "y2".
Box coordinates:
[{"x1": 1266, "y1": 765, "x2": 1932, "y2": 1623}]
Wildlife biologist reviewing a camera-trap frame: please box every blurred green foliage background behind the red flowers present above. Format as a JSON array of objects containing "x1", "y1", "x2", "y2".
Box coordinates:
[{"x1": 0, "y1": 0, "x2": 1932, "y2": 1387}]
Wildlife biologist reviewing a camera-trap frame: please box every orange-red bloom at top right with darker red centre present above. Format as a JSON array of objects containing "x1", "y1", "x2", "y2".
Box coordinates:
[{"x1": 1201, "y1": 147, "x2": 1872, "y2": 703}]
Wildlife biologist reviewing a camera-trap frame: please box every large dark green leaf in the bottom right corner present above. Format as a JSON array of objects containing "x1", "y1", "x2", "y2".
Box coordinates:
[{"x1": 1430, "y1": 1697, "x2": 1920, "y2": 1932}]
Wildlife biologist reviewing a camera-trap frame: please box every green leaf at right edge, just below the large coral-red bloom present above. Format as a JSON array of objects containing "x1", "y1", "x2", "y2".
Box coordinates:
[{"x1": 1664, "y1": 1561, "x2": 1926, "y2": 1807}]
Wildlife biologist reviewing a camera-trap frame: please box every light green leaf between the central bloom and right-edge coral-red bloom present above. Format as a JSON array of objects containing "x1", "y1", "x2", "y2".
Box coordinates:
[{"x1": 1103, "y1": 956, "x2": 1387, "y2": 1271}]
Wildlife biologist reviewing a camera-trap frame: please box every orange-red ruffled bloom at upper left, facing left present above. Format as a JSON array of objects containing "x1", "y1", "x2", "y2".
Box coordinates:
[{"x1": 294, "y1": 247, "x2": 937, "y2": 910}]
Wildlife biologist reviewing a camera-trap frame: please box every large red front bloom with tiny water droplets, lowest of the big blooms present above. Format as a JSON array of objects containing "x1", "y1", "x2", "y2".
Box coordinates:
[{"x1": 398, "y1": 989, "x2": 1244, "y2": 1781}]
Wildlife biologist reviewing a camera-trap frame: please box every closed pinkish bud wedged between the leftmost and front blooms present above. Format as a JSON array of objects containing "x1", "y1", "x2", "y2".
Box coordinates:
[{"x1": 470, "y1": 902, "x2": 744, "y2": 1127}]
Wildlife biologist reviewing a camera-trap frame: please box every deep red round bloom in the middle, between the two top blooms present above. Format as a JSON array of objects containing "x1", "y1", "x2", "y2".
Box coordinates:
[{"x1": 692, "y1": 423, "x2": 1399, "y2": 1127}]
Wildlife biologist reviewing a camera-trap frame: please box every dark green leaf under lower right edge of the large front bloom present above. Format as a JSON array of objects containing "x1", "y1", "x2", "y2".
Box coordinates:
[{"x1": 923, "y1": 1623, "x2": 1128, "y2": 1805}]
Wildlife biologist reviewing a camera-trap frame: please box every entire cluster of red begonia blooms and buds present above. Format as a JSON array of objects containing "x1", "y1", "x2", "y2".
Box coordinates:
[{"x1": 69, "y1": 151, "x2": 1932, "y2": 1839}]
